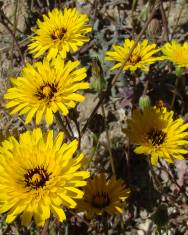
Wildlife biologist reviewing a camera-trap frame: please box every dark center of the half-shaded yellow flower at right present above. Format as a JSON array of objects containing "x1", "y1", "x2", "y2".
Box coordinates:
[{"x1": 147, "y1": 128, "x2": 166, "y2": 146}]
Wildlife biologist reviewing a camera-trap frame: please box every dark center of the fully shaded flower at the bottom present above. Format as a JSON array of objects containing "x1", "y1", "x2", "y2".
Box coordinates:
[{"x1": 91, "y1": 192, "x2": 110, "y2": 209}]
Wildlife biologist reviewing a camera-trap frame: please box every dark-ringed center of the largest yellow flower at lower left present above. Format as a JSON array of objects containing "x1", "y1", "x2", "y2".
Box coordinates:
[{"x1": 24, "y1": 167, "x2": 51, "y2": 189}]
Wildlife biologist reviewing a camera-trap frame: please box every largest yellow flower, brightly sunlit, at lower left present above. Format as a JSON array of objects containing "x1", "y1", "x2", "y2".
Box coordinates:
[{"x1": 0, "y1": 129, "x2": 89, "y2": 226}]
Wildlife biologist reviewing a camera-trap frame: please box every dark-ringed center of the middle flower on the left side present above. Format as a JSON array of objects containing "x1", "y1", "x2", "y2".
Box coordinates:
[{"x1": 35, "y1": 83, "x2": 57, "y2": 101}]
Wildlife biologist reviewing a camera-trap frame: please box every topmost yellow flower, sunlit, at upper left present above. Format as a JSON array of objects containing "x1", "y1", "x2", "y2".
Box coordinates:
[{"x1": 28, "y1": 8, "x2": 92, "y2": 60}]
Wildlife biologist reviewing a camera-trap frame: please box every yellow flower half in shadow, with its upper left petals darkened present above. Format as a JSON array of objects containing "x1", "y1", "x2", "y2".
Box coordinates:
[{"x1": 125, "y1": 107, "x2": 188, "y2": 165}]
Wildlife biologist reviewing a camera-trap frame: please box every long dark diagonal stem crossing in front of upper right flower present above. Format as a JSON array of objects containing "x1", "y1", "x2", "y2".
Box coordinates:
[{"x1": 81, "y1": 0, "x2": 160, "y2": 136}]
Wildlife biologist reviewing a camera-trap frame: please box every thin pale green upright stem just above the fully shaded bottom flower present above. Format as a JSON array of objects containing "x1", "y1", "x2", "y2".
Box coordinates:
[{"x1": 101, "y1": 103, "x2": 116, "y2": 176}]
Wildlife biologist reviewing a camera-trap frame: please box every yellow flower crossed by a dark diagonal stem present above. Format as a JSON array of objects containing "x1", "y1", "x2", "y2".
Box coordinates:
[{"x1": 105, "y1": 39, "x2": 160, "y2": 72}]
